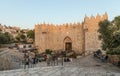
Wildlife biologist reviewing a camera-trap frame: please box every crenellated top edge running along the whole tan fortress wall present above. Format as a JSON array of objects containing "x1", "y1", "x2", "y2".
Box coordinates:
[{"x1": 35, "y1": 13, "x2": 108, "y2": 29}]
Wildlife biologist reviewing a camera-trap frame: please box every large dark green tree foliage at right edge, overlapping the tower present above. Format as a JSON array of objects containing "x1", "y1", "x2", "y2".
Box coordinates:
[{"x1": 98, "y1": 16, "x2": 120, "y2": 55}]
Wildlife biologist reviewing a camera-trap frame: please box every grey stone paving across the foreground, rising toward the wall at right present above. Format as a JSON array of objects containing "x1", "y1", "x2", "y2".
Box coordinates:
[{"x1": 0, "y1": 55, "x2": 120, "y2": 76}]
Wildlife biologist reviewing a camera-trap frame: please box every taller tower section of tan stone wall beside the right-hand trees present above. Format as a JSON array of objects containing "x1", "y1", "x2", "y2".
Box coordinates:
[{"x1": 84, "y1": 13, "x2": 108, "y2": 53}]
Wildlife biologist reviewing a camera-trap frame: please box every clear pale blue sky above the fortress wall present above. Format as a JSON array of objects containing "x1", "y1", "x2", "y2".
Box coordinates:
[{"x1": 0, "y1": 0, "x2": 120, "y2": 29}]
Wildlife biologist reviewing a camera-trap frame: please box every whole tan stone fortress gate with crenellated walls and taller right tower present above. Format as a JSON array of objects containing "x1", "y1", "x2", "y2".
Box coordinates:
[{"x1": 35, "y1": 13, "x2": 108, "y2": 54}]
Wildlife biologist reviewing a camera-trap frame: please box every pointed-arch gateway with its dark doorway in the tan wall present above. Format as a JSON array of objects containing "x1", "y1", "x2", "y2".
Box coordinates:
[{"x1": 63, "y1": 36, "x2": 72, "y2": 51}]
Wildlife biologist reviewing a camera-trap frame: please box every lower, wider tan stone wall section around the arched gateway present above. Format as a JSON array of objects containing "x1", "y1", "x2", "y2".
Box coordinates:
[{"x1": 35, "y1": 23, "x2": 82, "y2": 52}]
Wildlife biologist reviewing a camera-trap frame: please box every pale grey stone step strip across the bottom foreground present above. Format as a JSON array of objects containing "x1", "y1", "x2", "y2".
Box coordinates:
[{"x1": 0, "y1": 66, "x2": 120, "y2": 76}]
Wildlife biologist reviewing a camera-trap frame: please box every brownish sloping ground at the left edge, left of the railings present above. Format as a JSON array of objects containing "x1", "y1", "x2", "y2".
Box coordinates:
[{"x1": 0, "y1": 48, "x2": 23, "y2": 70}]
